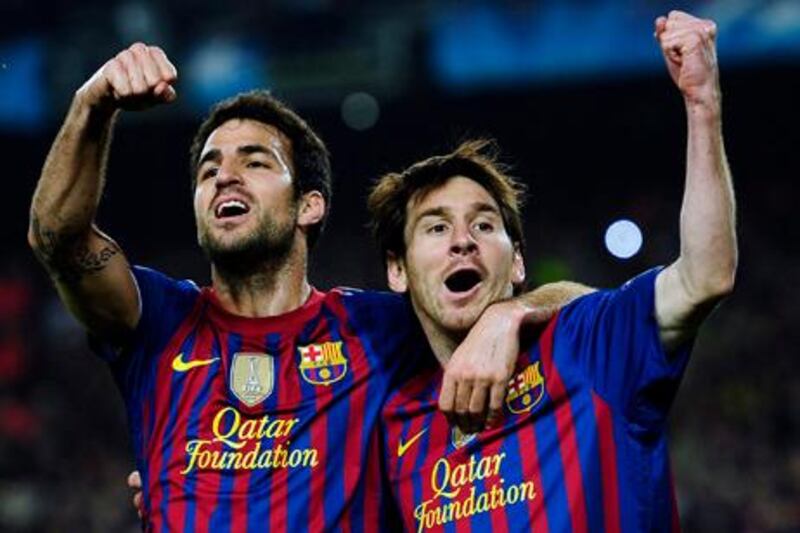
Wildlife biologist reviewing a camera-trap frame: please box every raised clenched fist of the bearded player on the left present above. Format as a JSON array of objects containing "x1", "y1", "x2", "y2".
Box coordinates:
[{"x1": 76, "y1": 43, "x2": 178, "y2": 110}]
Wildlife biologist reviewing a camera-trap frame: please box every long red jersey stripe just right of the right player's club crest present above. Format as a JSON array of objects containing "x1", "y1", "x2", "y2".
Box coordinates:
[{"x1": 540, "y1": 317, "x2": 588, "y2": 533}]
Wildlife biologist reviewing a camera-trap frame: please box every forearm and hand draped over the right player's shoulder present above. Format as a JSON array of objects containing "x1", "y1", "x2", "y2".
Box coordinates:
[{"x1": 439, "y1": 281, "x2": 594, "y2": 433}]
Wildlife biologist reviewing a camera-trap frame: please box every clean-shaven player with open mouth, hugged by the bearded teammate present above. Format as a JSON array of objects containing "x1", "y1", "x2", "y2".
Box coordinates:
[{"x1": 369, "y1": 12, "x2": 737, "y2": 532}]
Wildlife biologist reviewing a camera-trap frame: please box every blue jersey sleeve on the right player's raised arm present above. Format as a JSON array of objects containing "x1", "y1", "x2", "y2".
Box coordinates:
[{"x1": 555, "y1": 268, "x2": 692, "y2": 431}]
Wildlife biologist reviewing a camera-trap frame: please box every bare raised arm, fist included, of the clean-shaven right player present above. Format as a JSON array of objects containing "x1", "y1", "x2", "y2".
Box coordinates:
[{"x1": 655, "y1": 11, "x2": 737, "y2": 351}]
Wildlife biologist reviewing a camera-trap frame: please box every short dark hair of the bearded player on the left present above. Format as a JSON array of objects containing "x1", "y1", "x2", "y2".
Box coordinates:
[{"x1": 189, "y1": 89, "x2": 331, "y2": 248}]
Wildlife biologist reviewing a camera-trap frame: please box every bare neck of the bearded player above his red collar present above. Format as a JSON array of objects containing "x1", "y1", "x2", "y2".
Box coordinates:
[{"x1": 211, "y1": 237, "x2": 311, "y2": 318}]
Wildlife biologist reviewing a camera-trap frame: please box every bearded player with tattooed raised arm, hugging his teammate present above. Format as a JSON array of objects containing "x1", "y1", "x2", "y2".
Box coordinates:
[{"x1": 29, "y1": 43, "x2": 580, "y2": 531}]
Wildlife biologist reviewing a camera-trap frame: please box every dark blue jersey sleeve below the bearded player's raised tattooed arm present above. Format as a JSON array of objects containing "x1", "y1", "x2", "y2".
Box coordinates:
[{"x1": 90, "y1": 266, "x2": 200, "y2": 367}]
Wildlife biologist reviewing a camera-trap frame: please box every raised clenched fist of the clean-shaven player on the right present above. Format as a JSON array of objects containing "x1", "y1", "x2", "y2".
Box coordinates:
[{"x1": 655, "y1": 11, "x2": 719, "y2": 105}]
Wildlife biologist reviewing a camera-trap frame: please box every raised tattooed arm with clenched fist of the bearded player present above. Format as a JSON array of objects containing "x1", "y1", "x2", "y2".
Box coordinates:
[{"x1": 28, "y1": 43, "x2": 176, "y2": 341}]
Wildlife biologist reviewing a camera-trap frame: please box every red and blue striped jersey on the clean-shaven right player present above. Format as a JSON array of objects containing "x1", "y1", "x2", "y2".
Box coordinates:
[{"x1": 382, "y1": 270, "x2": 689, "y2": 533}]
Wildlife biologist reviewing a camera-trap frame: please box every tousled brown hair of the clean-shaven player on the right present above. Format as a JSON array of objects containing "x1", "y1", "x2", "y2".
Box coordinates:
[{"x1": 367, "y1": 139, "x2": 525, "y2": 261}]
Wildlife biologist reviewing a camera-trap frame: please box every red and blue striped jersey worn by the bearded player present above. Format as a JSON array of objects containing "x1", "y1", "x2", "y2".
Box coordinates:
[{"x1": 96, "y1": 267, "x2": 413, "y2": 533}]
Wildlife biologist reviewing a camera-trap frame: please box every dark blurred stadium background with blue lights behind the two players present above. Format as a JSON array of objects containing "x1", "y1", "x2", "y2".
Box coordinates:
[{"x1": 0, "y1": 0, "x2": 800, "y2": 532}]
